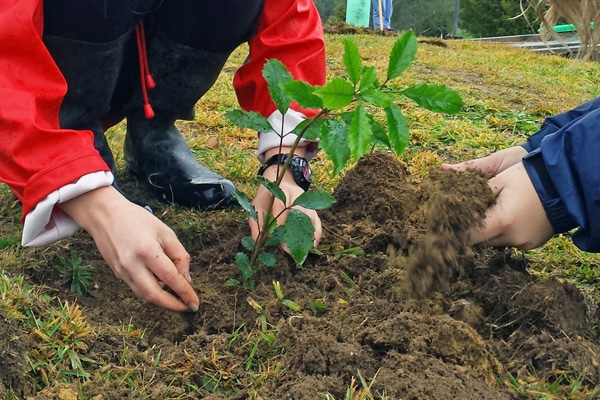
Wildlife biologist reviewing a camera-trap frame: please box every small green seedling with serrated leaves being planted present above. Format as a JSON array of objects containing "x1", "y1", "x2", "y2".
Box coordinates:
[{"x1": 227, "y1": 30, "x2": 462, "y2": 288}]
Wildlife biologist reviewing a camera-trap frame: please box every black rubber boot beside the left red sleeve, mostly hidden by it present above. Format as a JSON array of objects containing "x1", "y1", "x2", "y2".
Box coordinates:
[{"x1": 43, "y1": 33, "x2": 131, "y2": 179}]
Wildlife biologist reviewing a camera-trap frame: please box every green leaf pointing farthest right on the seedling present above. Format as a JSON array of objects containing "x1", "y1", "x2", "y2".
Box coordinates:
[{"x1": 401, "y1": 83, "x2": 462, "y2": 114}]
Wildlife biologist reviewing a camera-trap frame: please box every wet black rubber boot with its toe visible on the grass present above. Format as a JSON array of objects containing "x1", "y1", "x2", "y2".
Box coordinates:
[{"x1": 124, "y1": 34, "x2": 235, "y2": 210}]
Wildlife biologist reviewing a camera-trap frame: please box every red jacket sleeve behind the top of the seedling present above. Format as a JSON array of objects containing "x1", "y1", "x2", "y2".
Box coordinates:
[{"x1": 233, "y1": 0, "x2": 325, "y2": 117}]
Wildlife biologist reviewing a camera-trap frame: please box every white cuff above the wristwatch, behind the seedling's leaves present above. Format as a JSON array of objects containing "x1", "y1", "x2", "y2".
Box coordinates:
[{"x1": 258, "y1": 109, "x2": 319, "y2": 163}]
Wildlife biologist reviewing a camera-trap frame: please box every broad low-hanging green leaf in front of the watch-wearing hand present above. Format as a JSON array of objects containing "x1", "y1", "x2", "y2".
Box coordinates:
[{"x1": 281, "y1": 209, "x2": 315, "y2": 265}]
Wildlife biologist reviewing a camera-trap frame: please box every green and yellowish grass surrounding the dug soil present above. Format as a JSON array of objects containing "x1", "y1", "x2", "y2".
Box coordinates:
[{"x1": 0, "y1": 35, "x2": 600, "y2": 400}]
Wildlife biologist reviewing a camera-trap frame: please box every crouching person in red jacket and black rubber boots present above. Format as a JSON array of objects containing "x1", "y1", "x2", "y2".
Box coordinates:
[{"x1": 0, "y1": 0, "x2": 325, "y2": 311}]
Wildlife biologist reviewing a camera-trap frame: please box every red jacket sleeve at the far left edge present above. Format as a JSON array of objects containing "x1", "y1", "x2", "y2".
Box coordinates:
[{"x1": 0, "y1": 0, "x2": 109, "y2": 217}]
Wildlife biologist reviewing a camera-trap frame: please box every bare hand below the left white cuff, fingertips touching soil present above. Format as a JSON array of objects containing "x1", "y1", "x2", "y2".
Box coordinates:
[{"x1": 60, "y1": 186, "x2": 200, "y2": 311}]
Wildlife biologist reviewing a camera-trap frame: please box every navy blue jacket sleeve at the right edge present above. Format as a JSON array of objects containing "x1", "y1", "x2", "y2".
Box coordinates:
[{"x1": 523, "y1": 104, "x2": 600, "y2": 252}]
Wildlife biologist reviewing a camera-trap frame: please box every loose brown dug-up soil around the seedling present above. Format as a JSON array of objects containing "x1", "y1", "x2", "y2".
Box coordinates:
[{"x1": 0, "y1": 153, "x2": 600, "y2": 399}]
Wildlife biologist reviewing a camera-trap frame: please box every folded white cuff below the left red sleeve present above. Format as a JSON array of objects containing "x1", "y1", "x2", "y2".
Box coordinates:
[{"x1": 21, "y1": 171, "x2": 114, "y2": 246}]
